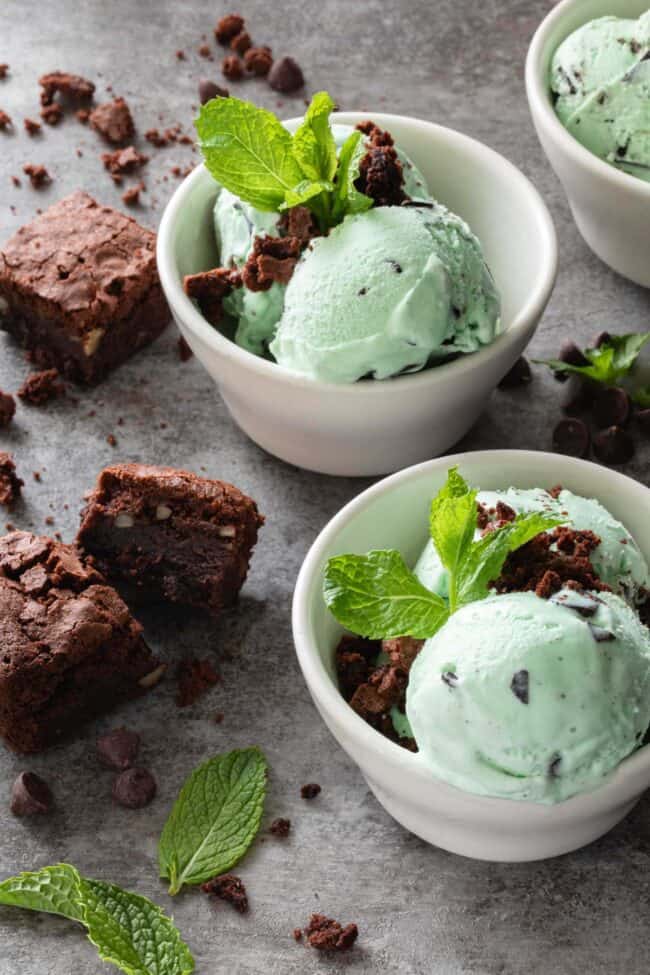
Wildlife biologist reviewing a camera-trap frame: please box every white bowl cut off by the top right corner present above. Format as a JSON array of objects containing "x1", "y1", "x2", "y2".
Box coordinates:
[{"x1": 526, "y1": 0, "x2": 650, "y2": 288}]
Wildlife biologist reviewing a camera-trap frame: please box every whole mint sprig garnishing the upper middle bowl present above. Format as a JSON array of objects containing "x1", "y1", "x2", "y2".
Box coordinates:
[{"x1": 195, "y1": 92, "x2": 373, "y2": 231}]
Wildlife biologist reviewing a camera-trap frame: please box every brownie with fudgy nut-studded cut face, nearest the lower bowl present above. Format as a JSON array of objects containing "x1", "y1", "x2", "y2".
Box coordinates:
[{"x1": 77, "y1": 464, "x2": 264, "y2": 615}]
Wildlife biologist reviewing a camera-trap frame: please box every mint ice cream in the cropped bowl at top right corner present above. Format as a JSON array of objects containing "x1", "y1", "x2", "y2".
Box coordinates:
[{"x1": 550, "y1": 10, "x2": 650, "y2": 182}]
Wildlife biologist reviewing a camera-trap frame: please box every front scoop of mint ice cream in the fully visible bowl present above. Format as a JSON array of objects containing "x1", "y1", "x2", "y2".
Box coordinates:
[{"x1": 270, "y1": 204, "x2": 500, "y2": 383}]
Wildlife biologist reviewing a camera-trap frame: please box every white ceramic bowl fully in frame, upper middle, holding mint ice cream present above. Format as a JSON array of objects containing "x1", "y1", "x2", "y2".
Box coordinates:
[{"x1": 158, "y1": 112, "x2": 557, "y2": 475}]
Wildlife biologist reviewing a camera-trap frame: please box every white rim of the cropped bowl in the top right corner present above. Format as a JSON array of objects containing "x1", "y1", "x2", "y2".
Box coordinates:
[{"x1": 525, "y1": 0, "x2": 650, "y2": 201}]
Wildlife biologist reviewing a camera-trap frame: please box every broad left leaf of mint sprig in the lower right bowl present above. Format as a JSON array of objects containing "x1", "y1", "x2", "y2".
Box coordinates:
[{"x1": 323, "y1": 550, "x2": 449, "y2": 640}]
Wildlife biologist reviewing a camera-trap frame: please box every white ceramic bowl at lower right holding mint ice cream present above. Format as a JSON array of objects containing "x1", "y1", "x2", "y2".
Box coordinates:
[{"x1": 293, "y1": 450, "x2": 650, "y2": 861}]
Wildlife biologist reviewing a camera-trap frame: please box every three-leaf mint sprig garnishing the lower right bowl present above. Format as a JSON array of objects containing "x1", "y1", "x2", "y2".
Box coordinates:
[{"x1": 323, "y1": 467, "x2": 562, "y2": 640}]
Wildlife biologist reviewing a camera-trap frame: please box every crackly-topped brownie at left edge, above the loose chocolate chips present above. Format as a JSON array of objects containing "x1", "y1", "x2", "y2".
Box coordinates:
[{"x1": 0, "y1": 531, "x2": 161, "y2": 753}]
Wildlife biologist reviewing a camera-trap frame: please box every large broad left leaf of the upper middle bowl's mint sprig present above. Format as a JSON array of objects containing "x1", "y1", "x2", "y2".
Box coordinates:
[{"x1": 195, "y1": 98, "x2": 303, "y2": 211}]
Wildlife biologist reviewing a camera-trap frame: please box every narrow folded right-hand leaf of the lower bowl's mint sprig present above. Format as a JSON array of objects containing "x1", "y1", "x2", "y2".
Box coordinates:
[{"x1": 456, "y1": 512, "x2": 562, "y2": 607}]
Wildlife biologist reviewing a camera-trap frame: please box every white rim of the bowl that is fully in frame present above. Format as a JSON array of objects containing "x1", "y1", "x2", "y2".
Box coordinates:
[{"x1": 156, "y1": 111, "x2": 558, "y2": 398}]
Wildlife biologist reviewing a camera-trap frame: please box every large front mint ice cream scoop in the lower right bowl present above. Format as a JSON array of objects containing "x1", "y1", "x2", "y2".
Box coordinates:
[{"x1": 406, "y1": 590, "x2": 650, "y2": 803}]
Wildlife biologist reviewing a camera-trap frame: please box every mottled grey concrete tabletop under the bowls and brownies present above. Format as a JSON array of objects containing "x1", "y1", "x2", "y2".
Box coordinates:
[{"x1": 0, "y1": 0, "x2": 650, "y2": 975}]
